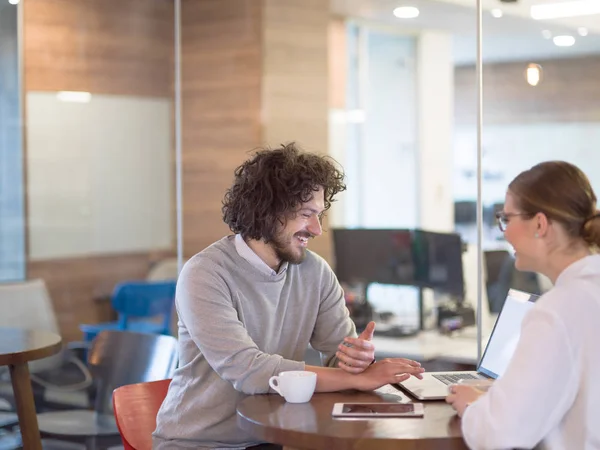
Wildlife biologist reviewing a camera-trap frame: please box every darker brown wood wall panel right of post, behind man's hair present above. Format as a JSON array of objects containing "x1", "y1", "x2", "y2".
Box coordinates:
[{"x1": 182, "y1": 0, "x2": 262, "y2": 253}]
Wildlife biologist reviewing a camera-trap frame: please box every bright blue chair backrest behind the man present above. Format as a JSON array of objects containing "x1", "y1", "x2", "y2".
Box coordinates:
[{"x1": 112, "y1": 280, "x2": 177, "y2": 329}]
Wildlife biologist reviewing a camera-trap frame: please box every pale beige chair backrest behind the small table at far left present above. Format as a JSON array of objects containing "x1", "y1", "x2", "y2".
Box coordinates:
[{"x1": 0, "y1": 280, "x2": 64, "y2": 373}]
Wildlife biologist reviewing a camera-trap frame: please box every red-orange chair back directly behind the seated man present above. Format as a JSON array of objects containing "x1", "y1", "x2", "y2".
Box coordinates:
[{"x1": 113, "y1": 379, "x2": 171, "y2": 450}]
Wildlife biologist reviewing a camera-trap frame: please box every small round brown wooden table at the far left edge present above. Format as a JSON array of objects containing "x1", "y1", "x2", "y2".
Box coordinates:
[{"x1": 0, "y1": 328, "x2": 62, "y2": 450}]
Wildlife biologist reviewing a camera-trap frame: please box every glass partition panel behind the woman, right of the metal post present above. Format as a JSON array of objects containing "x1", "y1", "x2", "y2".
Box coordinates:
[{"x1": 478, "y1": 2, "x2": 600, "y2": 312}]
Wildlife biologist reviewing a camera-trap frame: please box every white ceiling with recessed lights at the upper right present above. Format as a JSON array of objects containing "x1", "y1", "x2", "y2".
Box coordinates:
[{"x1": 331, "y1": 0, "x2": 600, "y2": 64}]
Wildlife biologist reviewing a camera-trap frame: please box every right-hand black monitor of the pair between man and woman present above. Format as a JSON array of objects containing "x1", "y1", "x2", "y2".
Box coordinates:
[{"x1": 413, "y1": 230, "x2": 465, "y2": 300}]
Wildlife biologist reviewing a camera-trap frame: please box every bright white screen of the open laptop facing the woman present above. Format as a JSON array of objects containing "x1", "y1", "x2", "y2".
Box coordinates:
[{"x1": 477, "y1": 289, "x2": 538, "y2": 378}]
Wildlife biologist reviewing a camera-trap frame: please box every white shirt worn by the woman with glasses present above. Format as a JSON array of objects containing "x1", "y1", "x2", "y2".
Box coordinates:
[{"x1": 462, "y1": 255, "x2": 600, "y2": 450}]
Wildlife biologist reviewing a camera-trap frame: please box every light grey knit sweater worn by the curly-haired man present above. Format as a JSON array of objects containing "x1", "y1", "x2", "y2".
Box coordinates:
[{"x1": 154, "y1": 236, "x2": 356, "y2": 449}]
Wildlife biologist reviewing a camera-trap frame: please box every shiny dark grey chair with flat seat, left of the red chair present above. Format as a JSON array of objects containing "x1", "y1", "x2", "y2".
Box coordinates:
[{"x1": 38, "y1": 331, "x2": 177, "y2": 449}]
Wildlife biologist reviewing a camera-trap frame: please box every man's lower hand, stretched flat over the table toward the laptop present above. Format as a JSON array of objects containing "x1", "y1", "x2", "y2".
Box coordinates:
[{"x1": 354, "y1": 358, "x2": 425, "y2": 391}]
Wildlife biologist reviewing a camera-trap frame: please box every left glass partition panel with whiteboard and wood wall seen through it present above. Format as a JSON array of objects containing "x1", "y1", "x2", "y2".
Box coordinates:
[{"x1": 0, "y1": 0, "x2": 177, "y2": 341}]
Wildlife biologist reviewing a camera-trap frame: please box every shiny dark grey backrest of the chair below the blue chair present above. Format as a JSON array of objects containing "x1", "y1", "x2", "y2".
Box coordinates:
[{"x1": 88, "y1": 331, "x2": 177, "y2": 414}]
